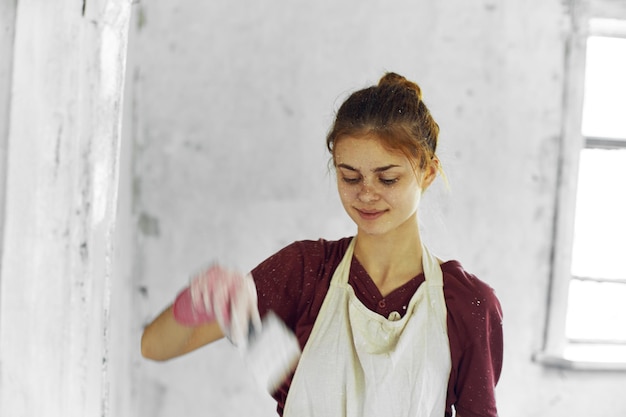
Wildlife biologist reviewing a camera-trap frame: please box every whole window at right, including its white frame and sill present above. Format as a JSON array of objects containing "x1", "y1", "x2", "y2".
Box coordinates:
[{"x1": 536, "y1": 16, "x2": 626, "y2": 370}]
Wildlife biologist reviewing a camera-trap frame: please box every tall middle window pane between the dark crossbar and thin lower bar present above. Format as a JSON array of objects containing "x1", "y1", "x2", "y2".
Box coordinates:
[{"x1": 572, "y1": 149, "x2": 626, "y2": 280}]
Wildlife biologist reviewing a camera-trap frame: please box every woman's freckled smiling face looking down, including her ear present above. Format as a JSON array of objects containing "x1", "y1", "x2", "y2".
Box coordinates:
[{"x1": 335, "y1": 135, "x2": 436, "y2": 235}]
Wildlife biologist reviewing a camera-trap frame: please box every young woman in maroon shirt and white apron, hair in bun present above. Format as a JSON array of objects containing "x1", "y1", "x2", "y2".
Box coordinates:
[{"x1": 142, "y1": 73, "x2": 502, "y2": 417}]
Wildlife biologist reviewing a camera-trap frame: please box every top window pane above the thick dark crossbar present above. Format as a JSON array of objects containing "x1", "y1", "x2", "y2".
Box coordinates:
[{"x1": 582, "y1": 36, "x2": 626, "y2": 138}]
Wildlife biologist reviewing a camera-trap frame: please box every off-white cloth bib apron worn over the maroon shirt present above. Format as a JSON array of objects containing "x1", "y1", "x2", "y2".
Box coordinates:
[{"x1": 284, "y1": 239, "x2": 451, "y2": 417}]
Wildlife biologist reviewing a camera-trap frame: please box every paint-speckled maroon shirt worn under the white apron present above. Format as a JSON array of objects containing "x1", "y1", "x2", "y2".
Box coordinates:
[{"x1": 252, "y1": 238, "x2": 503, "y2": 417}]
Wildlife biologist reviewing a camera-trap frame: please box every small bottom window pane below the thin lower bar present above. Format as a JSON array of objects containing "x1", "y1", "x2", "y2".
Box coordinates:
[{"x1": 565, "y1": 279, "x2": 626, "y2": 343}]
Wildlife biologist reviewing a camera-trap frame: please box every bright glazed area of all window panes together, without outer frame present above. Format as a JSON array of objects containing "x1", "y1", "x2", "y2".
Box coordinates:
[{"x1": 565, "y1": 36, "x2": 626, "y2": 362}]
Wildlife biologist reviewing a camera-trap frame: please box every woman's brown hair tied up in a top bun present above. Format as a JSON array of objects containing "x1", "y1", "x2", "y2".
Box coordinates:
[{"x1": 326, "y1": 72, "x2": 439, "y2": 170}]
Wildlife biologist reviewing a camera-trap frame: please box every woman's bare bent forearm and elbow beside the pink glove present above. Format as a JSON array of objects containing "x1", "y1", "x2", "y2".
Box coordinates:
[{"x1": 141, "y1": 306, "x2": 224, "y2": 361}]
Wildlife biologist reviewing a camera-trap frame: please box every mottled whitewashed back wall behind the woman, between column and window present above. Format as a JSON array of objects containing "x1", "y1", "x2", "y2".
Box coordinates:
[{"x1": 123, "y1": 0, "x2": 626, "y2": 417}]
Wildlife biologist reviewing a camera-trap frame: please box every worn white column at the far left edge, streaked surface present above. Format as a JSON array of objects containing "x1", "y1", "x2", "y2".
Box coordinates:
[{"x1": 0, "y1": 0, "x2": 131, "y2": 417}]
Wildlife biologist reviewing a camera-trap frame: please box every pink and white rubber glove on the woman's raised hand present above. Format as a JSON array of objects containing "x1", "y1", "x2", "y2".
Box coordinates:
[{"x1": 173, "y1": 265, "x2": 261, "y2": 347}]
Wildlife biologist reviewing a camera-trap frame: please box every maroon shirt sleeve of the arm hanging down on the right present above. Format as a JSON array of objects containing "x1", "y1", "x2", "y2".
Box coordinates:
[{"x1": 448, "y1": 274, "x2": 503, "y2": 417}]
